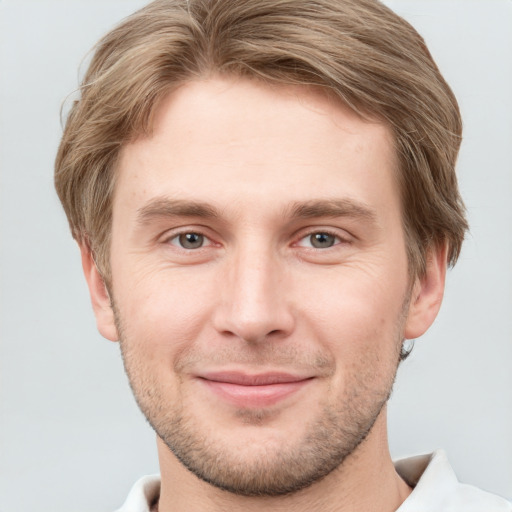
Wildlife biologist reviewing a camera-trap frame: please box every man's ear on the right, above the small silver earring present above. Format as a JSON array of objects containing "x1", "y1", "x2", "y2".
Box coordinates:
[{"x1": 404, "y1": 243, "x2": 448, "y2": 340}]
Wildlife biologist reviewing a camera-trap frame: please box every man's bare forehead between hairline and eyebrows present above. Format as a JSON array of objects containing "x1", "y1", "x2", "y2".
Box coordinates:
[{"x1": 114, "y1": 78, "x2": 397, "y2": 218}]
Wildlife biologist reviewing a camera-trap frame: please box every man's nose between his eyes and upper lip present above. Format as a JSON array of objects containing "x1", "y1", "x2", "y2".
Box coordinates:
[{"x1": 213, "y1": 244, "x2": 295, "y2": 343}]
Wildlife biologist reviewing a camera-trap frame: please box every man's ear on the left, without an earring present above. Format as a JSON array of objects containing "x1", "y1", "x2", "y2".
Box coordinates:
[{"x1": 79, "y1": 243, "x2": 119, "y2": 341}]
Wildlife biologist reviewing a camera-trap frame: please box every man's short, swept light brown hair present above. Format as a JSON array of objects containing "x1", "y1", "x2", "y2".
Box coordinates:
[{"x1": 55, "y1": 0, "x2": 467, "y2": 280}]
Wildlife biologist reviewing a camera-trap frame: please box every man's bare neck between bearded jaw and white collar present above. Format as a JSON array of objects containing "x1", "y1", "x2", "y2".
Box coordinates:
[{"x1": 158, "y1": 408, "x2": 411, "y2": 512}]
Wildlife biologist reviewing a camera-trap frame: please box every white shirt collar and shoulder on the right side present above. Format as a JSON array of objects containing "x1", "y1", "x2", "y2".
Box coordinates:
[{"x1": 395, "y1": 450, "x2": 512, "y2": 512}]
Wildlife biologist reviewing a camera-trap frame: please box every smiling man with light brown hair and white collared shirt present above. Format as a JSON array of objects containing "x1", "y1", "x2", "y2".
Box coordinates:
[{"x1": 56, "y1": 0, "x2": 512, "y2": 512}]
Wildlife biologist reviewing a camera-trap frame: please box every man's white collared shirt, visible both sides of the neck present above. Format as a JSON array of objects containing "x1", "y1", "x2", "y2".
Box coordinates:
[{"x1": 116, "y1": 450, "x2": 512, "y2": 512}]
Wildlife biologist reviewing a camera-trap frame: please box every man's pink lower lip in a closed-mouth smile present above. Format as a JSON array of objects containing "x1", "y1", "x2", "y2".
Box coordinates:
[{"x1": 201, "y1": 379, "x2": 312, "y2": 407}]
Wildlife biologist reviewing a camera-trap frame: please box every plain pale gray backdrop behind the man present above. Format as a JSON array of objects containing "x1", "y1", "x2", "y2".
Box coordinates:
[{"x1": 0, "y1": 0, "x2": 512, "y2": 512}]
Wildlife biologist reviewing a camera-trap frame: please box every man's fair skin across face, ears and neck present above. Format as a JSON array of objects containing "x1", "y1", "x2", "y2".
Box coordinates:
[{"x1": 82, "y1": 78, "x2": 446, "y2": 512}]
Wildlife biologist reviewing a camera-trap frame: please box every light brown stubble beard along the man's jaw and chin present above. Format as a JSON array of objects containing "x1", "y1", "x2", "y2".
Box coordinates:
[{"x1": 114, "y1": 301, "x2": 408, "y2": 497}]
